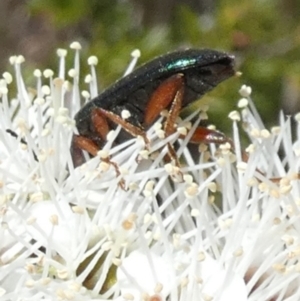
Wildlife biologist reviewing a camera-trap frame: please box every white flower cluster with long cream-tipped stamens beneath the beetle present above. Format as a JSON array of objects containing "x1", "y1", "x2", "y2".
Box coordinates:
[{"x1": 0, "y1": 43, "x2": 300, "y2": 301}]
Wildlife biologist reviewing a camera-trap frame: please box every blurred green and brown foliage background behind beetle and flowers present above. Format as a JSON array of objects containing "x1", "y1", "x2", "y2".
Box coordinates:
[{"x1": 0, "y1": 0, "x2": 300, "y2": 132}]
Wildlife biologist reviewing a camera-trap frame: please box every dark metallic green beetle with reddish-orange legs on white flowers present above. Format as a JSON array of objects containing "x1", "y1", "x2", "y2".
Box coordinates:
[{"x1": 71, "y1": 49, "x2": 235, "y2": 167}]
